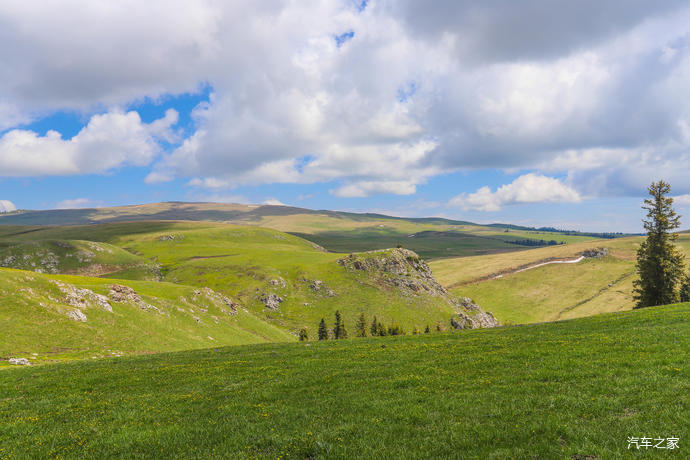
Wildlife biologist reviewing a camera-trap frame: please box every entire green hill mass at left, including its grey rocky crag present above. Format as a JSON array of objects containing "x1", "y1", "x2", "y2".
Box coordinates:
[{"x1": 0, "y1": 222, "x2": 495, "y2": 359}]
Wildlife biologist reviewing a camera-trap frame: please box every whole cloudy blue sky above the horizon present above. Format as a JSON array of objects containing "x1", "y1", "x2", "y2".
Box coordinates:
[{"x1": 0, "y1": 0, "x2": 690, "y2": 232}]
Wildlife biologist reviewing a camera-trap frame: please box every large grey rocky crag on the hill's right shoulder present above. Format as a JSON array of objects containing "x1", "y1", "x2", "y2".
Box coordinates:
[{"x1": 337, "y1": 248, "x2": 498, "y2": 329}]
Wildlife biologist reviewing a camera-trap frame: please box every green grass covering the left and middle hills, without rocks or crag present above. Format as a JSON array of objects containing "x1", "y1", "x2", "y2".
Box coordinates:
[{"x1": 0, "y1": 222, "x2": 462, "y2": 359}]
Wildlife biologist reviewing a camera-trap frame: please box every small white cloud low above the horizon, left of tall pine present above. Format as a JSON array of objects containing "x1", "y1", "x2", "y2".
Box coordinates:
[{"x1": 449, "y1": 173, "x2": 582, "y2": 211}]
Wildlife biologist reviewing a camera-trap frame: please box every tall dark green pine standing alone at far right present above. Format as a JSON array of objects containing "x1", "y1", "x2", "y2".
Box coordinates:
[{"x1": 633, "y1": 181, "x2": 685, "y2": 308}]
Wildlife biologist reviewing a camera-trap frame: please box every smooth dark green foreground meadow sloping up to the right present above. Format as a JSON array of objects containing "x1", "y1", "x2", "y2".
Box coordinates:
[{"x1": 0, "y1": 304, "x2": 690, "y2": 459}]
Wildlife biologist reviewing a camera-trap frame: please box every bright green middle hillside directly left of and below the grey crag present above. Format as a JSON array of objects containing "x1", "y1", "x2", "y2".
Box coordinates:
[{"x1": 109, "y1": 226, "x2": 462, "y2": 336}]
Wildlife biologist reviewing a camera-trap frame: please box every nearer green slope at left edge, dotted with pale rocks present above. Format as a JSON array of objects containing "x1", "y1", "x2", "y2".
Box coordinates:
[{"x1": 0, "y1": 269, "x2": 295, "y2": 366}]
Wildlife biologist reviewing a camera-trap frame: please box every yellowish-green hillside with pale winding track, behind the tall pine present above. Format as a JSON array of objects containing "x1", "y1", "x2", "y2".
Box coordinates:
[{"x1": 430, "y1": 234, "x2": 690, "y2": 323}]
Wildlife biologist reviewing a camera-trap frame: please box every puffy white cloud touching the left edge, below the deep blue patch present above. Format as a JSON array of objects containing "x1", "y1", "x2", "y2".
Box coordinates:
[{"x1": 0, "y1": 110, "x2": 177, "y2": 176}]
